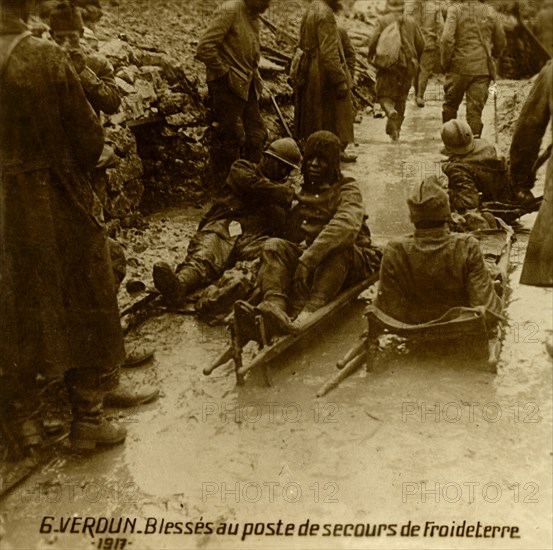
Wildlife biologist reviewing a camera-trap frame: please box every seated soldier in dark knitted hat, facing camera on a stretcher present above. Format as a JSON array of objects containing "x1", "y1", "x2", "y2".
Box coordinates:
[{"x1": 253, "y1": 131, "x2": 380, "y2": 332}]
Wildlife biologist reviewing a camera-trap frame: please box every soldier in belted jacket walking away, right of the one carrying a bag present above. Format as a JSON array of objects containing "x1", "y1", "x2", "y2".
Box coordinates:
[{"x1": 441, "y1": 0, "x2": 506, "y2": 138}]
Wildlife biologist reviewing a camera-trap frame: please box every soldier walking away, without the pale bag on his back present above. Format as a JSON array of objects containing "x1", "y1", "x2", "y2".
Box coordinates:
[{"x1": 369, "y1": 0, "x2": 424, "y2": 141}]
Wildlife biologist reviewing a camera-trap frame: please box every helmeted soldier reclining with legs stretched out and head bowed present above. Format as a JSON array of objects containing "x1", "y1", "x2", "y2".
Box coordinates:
[{"x1": 153, "y1": 138, "x2": 301, "y2": 307}]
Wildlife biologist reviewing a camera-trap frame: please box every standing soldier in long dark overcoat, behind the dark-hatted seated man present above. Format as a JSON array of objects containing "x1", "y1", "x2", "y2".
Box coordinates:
[{"x1": 294, "y1": 0, "x2": 355, "y2": 162}]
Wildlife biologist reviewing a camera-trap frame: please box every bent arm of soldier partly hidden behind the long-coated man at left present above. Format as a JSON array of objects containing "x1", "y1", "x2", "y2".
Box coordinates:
[{"x1": 79, "y1": 58, "x2": 121, "y2": 115}]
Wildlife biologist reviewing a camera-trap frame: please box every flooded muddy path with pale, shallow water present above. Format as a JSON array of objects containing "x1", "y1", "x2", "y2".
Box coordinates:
[{"x1": 2, "y1": 86, "x2": 553, "y2": 549}]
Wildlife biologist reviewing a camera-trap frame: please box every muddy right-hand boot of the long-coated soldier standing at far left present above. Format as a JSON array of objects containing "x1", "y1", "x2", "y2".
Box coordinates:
[{"x1": 68, "y1": 386, "x2": 127, "y2": 450}]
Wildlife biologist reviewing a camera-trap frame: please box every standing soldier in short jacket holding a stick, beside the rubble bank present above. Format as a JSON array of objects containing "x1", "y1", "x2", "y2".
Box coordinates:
[{"x1": 196, "y1": 0, "x2": 270, "y2": 185}]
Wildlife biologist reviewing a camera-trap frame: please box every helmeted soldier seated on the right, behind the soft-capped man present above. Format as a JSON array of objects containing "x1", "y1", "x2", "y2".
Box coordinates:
[{"x1": 442, "y1": 119, "x2": 511, "y2": 214}]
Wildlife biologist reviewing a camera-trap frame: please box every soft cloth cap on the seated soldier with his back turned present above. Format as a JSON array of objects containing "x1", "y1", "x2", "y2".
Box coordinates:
[{"x1": 407, "y1": 176, "x2": 451, "y2": 223}]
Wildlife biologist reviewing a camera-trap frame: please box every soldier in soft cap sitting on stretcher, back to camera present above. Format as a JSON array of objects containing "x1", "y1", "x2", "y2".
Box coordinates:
[{"x1": 375, "y1": 176, "x2": 501, "y2": 324}]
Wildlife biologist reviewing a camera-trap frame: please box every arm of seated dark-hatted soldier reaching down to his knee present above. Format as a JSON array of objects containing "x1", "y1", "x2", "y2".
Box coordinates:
[{"x1": 300, "y1": 181, "x2": 365, "y2": 270}]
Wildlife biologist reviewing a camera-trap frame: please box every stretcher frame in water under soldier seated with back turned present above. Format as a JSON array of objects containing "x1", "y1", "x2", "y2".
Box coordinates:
[{"x1": 317, "y1": 220, "x2": 514, "y2": 397}]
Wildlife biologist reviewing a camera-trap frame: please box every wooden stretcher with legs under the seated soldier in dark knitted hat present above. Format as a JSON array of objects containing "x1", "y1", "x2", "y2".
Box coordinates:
[{"x1": 203, "y1": 274, "x2": 378, "y2": 385}]
